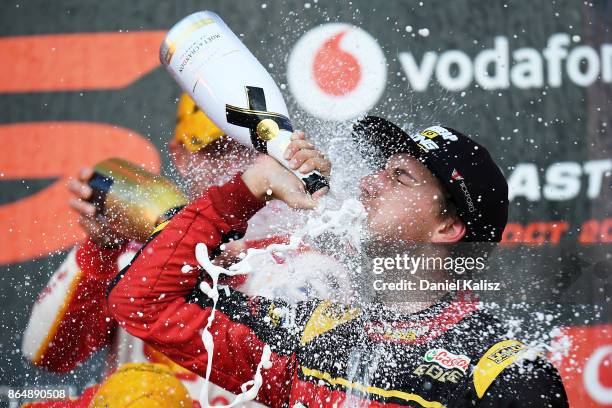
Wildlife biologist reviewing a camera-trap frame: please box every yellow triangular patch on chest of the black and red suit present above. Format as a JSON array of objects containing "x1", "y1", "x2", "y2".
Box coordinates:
[{"x1": 300, "y1": 300, "x2": 361, "y2": 345}]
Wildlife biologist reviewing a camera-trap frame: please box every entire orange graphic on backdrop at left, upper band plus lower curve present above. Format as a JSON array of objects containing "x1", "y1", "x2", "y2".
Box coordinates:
[{"x1": 0, "y1": 31, "x2": 165, "y2": 264}]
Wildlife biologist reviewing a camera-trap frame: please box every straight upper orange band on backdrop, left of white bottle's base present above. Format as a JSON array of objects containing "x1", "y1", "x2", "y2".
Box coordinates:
[{"x1": 0, "y1": 31, "x2": 165, "y2": 93}]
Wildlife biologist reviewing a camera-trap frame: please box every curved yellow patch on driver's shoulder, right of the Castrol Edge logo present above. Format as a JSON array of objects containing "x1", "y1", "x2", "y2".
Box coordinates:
[{"x1": 474, "y1": 340, "x2": 528, "y2": 398}]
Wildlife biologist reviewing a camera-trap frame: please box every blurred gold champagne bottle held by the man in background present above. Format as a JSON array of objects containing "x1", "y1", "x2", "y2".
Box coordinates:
[{"x1": 89, "y1": 158, "x2": 187, "y2": 242}]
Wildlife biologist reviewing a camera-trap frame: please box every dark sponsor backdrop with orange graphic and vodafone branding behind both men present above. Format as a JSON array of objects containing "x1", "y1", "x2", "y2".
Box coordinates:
[{"x1": 0, "y1": 0, "x2": 612, "y2": 407}]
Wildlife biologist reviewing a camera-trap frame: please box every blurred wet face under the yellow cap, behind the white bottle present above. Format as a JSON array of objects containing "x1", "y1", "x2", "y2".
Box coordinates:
[{"x1": 168, "y1": 137, "x2": 257, "y2": 196}]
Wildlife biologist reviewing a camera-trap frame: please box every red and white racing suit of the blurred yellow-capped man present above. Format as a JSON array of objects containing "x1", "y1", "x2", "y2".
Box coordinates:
[{"x1": 22, "y1": 217, "x2": 282, "y2": 407}]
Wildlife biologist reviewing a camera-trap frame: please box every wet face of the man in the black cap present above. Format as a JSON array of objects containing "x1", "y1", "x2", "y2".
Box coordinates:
[{"x1": 360, "y1": 153, "x2": 464, "y2": 242}]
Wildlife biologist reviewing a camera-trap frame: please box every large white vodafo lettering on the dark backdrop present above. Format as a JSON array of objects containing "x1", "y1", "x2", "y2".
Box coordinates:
[{"x1": 399, "y1": 33, "x2": 612, "y2": 92}]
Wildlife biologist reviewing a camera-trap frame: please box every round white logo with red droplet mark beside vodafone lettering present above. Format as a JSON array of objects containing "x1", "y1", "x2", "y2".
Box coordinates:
[{"x1": 287, "y1": 23, "x2": 387, "y2": 120}]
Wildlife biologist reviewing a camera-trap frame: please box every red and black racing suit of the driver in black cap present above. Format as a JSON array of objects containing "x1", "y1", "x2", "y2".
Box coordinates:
[{"x1": 108, "y1": 175, "x2": 567, "y2": 408}]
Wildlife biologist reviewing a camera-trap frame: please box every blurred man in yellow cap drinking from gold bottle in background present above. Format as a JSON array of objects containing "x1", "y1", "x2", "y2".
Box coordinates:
[{"x1": 22, "y1": 94, "x2": 282, "y2": 406}]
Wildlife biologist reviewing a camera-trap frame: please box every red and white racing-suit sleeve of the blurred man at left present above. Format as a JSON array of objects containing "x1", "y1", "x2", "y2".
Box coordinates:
[{"x1": 22, "y1": 239, "x2": 129, "y2": 373}]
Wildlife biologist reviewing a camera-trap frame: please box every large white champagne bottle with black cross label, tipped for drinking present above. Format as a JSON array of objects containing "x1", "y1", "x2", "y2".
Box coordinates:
[{"x1": 160, "y1": 11, "x2": 329, "y2": 194}]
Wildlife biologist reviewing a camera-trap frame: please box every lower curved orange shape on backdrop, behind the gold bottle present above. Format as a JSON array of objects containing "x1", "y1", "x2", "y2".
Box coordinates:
[{"x1": 0, "y1": 122, "x2": 160, "y2": 264}]
